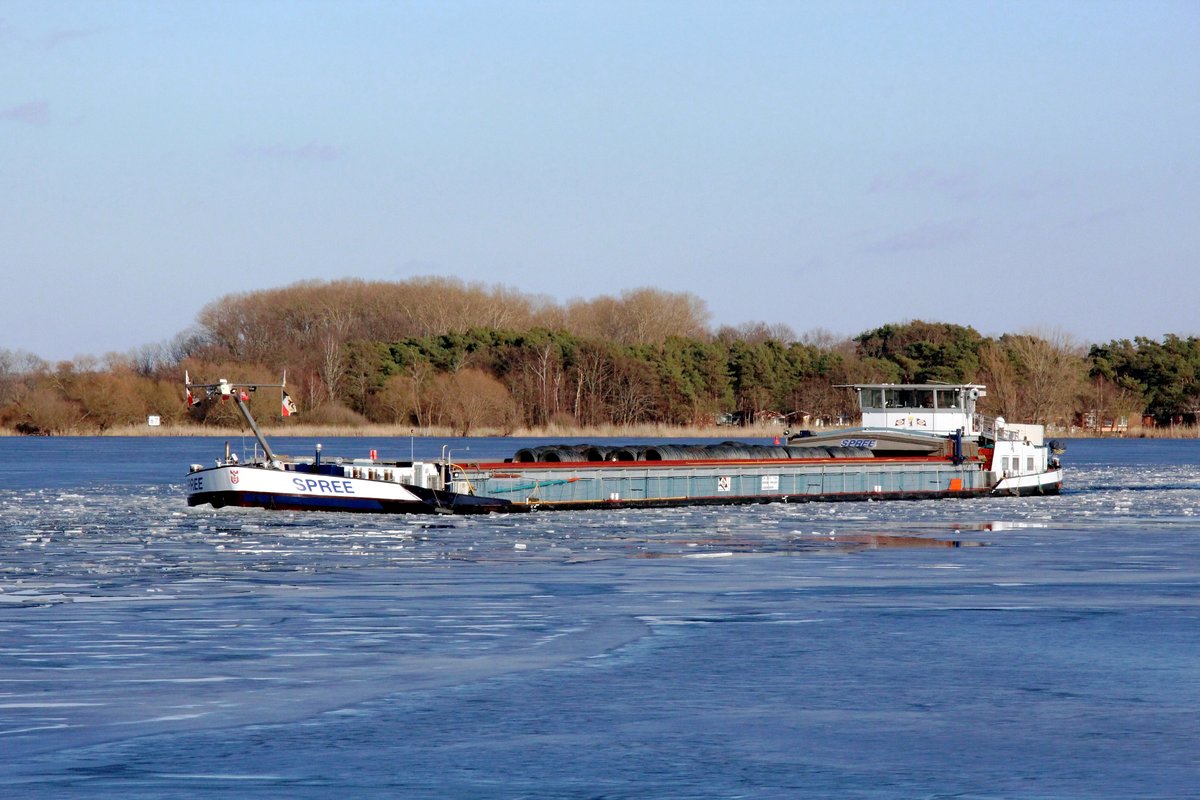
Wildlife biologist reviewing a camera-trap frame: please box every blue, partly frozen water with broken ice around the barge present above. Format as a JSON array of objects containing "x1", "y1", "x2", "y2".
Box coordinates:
[{"x1": 0, "y1": 438, "x2": 1200, "y2": 799}]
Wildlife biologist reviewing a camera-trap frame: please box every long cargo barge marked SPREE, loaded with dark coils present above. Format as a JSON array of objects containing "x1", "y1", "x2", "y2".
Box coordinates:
[{"x1": 185, "y1": 379, "x2": 1063, "y2": 513}]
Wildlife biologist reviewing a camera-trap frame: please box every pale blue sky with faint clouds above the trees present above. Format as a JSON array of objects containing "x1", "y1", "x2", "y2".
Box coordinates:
[{"x1": 0, "y1": 0, "x2": 1200, "y2": 360}]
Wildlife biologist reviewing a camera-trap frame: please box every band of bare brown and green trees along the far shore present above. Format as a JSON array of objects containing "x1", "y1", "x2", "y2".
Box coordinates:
[{"x1": 0, "y1": 277, "x2": 1200, "y2": 433}]
